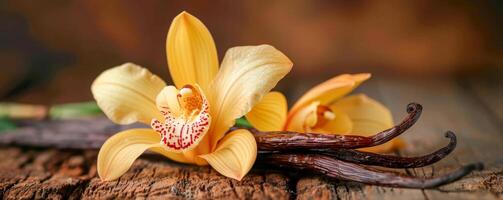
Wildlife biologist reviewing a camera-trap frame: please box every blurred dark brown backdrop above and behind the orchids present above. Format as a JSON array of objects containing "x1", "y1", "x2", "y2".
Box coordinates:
[{"x1": 0, "y1": 0, "x2": 503, "y2": 104}]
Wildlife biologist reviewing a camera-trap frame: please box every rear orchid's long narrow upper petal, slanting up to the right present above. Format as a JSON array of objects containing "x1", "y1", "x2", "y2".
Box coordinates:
[{"x1": 288, "y1": 73, "x2": 370, "y2": 120}]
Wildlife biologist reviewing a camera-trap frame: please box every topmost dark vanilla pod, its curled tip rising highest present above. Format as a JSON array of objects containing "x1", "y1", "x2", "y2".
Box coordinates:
[{"x1": 251, "y1": 103, "x2": 422, "y2": 151}]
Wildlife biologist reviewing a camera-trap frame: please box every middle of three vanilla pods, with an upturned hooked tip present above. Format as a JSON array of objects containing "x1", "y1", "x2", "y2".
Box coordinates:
[{"x1": 312, "y1": 131, "x2": 456, "y2": 168}]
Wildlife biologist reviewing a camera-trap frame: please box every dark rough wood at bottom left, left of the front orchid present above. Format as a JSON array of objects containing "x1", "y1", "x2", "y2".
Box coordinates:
[{"x1": 0, "y1": 147, "x2": 96, "y2": 199}]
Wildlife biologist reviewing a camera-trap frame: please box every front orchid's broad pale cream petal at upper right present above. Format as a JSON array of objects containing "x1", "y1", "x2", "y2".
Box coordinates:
[{"x1": 208, "y1": 45, "x2": 293, "y2": 148}]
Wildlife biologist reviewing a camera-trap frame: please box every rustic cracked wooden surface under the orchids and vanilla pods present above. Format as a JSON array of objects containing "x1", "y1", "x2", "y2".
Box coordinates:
[{"x1": 0, "y1": 76, "x2": 503, "y2": 199}]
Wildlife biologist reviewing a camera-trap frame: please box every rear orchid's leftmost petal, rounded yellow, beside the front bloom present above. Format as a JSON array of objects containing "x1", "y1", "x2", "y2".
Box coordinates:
[{"x1": 246, "y1": 92, "x2": 288, "y2": 131}]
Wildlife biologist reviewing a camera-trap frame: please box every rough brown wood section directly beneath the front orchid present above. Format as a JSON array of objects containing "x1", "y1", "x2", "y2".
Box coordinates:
[{"x1": 83, "y1": 159, "x2": 290, "y2": 199}]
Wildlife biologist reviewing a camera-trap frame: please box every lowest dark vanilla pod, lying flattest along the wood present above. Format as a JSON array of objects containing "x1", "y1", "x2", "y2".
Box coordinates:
[{"x1": 257, "y1": 153, "x2": 483, "y2": 189}]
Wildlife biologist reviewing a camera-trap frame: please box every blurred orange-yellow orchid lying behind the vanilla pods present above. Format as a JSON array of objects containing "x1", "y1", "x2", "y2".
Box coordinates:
[{"x1": 246, "y1": 74, "x2": 403, "y2": 152}]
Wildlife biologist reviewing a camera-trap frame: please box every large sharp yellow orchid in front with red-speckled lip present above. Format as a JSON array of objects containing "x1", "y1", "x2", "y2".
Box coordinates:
[{"x1": 91, "y1": 12, "x2": 292, "y2": 180}]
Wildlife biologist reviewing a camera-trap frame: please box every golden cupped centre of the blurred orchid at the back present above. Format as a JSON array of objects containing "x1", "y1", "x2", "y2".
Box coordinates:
[{"x1": 286, "y1": 101, "x2": 353, "y2": 134}]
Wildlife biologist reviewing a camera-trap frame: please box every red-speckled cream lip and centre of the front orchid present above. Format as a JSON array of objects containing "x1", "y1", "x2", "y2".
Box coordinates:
[{"x1": 151, "y1": 85, "x2": 211, "y2": 151}]
